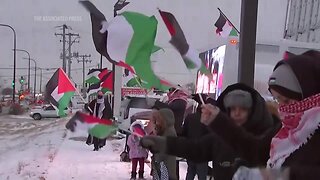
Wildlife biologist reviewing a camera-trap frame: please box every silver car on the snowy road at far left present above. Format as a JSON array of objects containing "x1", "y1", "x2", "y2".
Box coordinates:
[{"x1": 30, "y1": 105, "x2": 69, "y2": 120}]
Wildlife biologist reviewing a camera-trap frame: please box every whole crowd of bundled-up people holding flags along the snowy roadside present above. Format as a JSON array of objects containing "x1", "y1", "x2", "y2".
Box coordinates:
[{"x1": 87, "y1": 50, "x2": 320, "y2": 180}]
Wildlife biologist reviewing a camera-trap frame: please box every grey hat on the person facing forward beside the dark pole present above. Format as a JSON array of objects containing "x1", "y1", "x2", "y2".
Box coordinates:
[{"x1": 223, "y1": 90, "x2": 252, "y2": 108}]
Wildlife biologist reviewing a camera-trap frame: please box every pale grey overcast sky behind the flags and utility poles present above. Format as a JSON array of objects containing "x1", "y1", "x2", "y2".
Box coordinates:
[{"x1": 0, "y1": 0, "x2": 240, "y2": 90}]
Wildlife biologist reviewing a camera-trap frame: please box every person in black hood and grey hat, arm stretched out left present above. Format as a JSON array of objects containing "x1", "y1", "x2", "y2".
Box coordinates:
[{"x1": 141, "y1": 83, "x2": 280, "y2": 180}]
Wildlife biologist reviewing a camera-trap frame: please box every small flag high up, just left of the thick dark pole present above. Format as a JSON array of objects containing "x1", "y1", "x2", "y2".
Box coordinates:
[{"x1": 214, "y1": 11, "x2": 238, "y2": 37}]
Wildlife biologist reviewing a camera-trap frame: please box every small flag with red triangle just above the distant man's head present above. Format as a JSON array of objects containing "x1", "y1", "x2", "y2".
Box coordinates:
[{"x1": 87, "y1": 70, "x2": 114, "y2": 96}]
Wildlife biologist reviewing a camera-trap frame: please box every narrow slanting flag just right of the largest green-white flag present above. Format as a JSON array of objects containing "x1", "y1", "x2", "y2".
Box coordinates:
[{"x1": 159, "y1": 10, "x2": 211, "y2": 76}]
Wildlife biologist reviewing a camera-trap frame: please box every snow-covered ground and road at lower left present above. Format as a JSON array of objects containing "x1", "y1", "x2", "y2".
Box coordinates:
[{"x1": 0, "y1": 116, "x2": 190, "y2": 180}]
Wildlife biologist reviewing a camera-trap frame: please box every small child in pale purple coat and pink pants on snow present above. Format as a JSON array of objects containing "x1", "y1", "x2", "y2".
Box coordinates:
[{"x1": 128, "y1": 121, "x2": 148, "y2": 180}]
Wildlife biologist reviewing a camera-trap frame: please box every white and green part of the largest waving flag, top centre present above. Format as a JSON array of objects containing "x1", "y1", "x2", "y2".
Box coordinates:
[{"x1": 106, "y1": 12, "x2": 169, "y2": 89}]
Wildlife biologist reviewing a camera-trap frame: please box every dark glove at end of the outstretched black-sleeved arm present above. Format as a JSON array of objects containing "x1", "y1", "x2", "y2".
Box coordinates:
[{"x1": 140, "y1": 136, "x2": 167, "y2": 154}]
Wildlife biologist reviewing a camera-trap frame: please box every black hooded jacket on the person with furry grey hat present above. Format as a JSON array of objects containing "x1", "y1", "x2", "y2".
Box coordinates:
[{"x1": 167, "y1": 84, "x2": 281, "y2": 180}]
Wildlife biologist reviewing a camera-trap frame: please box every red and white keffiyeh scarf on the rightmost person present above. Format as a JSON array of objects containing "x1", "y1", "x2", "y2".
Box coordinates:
[{"x1": 267, "y1": 94, "x2": 320, "y2": 168}]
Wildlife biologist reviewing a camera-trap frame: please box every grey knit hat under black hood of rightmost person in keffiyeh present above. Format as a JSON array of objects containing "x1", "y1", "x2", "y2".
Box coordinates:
[{"x1": 268, "y1": 63, "x2": 302, "y2": 99}]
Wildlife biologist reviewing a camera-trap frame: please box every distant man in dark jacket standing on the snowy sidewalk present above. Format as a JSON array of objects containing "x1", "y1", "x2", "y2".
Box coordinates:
[{"x1": 86, "y1": 91, "x2": 113, "y2": 151}]
